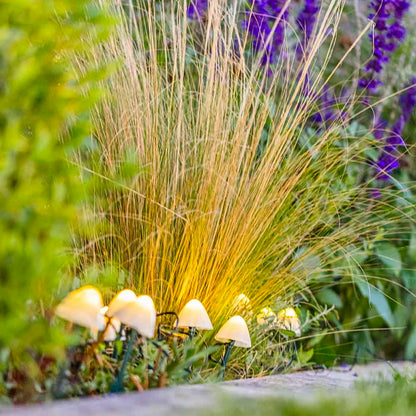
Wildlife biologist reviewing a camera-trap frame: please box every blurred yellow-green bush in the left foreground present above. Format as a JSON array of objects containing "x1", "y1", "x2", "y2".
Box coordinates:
[{"x1": 0, "y1": 0, "x2": 109, "y2": 373}]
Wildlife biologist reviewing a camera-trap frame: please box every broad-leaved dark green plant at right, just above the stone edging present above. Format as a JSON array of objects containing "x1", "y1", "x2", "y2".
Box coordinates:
[{"x1": 308, "y1": 206, "x2": 416, "y2": 365}]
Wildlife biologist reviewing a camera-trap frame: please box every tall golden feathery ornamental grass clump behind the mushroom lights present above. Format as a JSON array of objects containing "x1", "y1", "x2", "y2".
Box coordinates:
[{"x1": 74, "y1": 0, "x2": 394, "y2": 327}]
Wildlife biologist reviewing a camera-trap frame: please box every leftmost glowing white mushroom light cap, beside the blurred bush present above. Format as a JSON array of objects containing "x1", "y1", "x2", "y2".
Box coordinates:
[{"x1": 55, "y1": 286, "x2": 105, "y2": 330}]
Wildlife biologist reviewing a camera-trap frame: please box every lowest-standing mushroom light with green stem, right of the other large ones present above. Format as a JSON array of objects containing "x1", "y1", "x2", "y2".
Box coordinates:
[{"x1": 215, "y1": 315, "x2": 251, "y2": 375}]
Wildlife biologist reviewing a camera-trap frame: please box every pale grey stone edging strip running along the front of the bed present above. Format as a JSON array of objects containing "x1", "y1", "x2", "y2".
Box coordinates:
[{"x1": 0, "y1": 362, "x2": 416, "y2": 416}]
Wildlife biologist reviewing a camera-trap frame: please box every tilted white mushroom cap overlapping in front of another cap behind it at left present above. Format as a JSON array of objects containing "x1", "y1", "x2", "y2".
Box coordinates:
[{"x1": 110, "y1": 295, "x2": 156, "y2": 338}]
